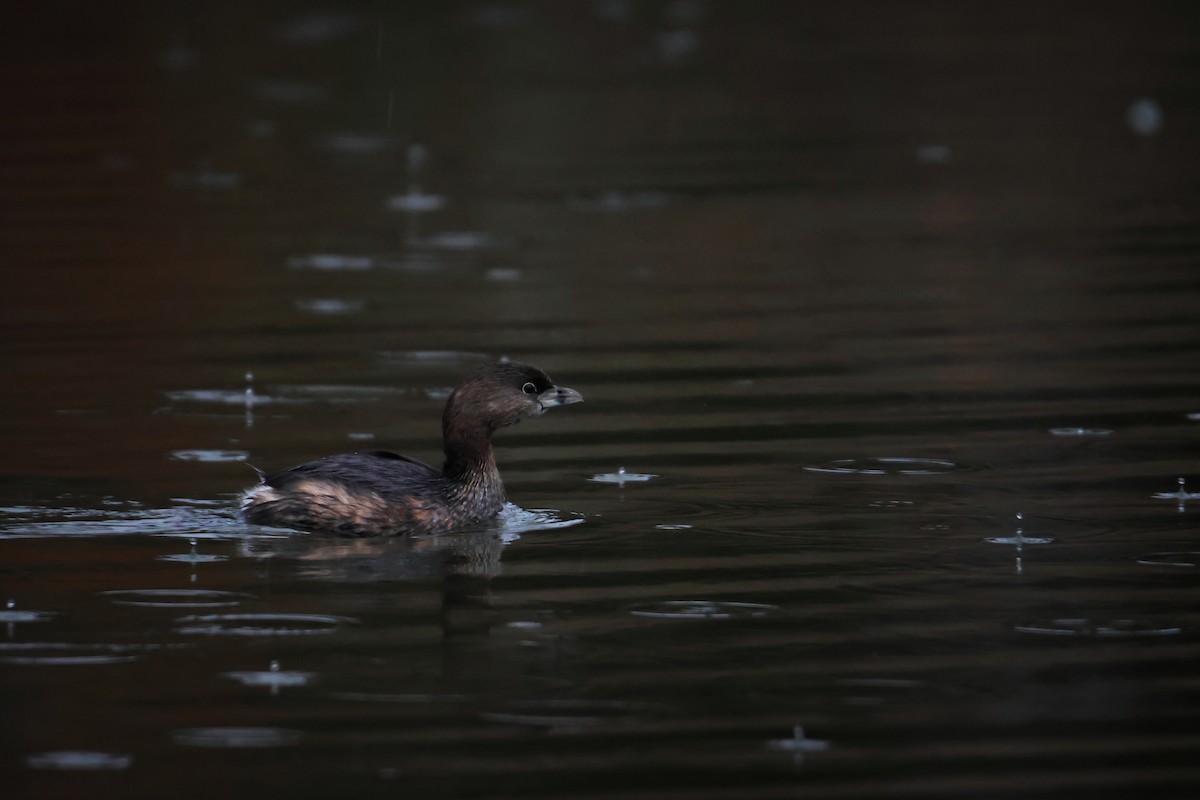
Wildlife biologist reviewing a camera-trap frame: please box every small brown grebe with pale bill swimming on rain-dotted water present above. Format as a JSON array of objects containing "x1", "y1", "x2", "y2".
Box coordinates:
[{"x1": 241, "y1": 363, "x2": 583, "y2": 536}]
